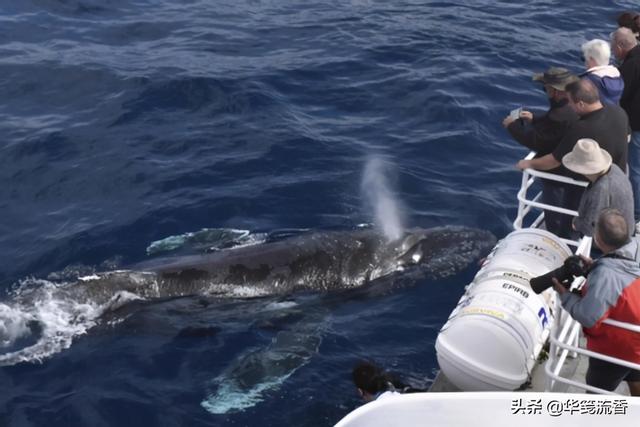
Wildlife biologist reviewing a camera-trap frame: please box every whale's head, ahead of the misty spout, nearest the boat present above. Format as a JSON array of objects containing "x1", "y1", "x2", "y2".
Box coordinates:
[{"x1": 395, "y1": 226, "x2": 496, "y2": 277}]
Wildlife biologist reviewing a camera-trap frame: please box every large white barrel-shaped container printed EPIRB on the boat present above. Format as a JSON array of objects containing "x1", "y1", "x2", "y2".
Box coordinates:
[{"x1": 436, "y1": 229, "x2": 571, "y2": 391}]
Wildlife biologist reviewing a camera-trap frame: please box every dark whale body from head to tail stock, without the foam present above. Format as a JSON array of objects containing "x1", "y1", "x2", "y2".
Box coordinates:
[{"x1": 76, "y1": 227, "x2": 495, "y2": 300}]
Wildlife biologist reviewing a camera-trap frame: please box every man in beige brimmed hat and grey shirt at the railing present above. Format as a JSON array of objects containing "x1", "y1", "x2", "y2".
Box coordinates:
[{"x1": 562, "y1": 138, "x2": 634, "y2": 236}]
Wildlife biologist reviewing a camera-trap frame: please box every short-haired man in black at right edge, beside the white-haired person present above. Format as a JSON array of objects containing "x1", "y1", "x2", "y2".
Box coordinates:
[{"x1": 611, "y1": 28, "x2": 640, "y2": 221}]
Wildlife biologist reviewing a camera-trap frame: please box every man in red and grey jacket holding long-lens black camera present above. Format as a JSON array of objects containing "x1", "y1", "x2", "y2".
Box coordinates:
[{"x1": 553, "y1": 209, "x2": 640, "y2": 396}]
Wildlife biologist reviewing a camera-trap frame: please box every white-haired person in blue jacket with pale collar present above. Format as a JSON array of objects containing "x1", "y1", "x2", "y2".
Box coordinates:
[{"x1": 580, "y1": 39, "x2": 624, "y2": 104}]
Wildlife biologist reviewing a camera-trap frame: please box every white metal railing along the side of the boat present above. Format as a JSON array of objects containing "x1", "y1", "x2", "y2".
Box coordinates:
[{"x1": 513, "y1": 152, "x2": 640, "y2": 395}]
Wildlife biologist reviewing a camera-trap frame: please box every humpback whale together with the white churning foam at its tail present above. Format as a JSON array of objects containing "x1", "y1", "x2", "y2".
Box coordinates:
[{"x1": 0, "y1": 227, "x2": 496, "y2": 365}]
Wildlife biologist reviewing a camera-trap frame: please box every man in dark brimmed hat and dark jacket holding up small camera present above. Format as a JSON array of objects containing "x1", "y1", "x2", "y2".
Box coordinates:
[{"x1": 502, "y1": 67, "x2": 578, "y2": 237}]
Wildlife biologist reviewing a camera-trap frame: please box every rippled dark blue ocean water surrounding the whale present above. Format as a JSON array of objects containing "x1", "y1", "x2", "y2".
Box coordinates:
[{"x1": 0, "y1": 0, "x2": 637, "y2": 426}]
